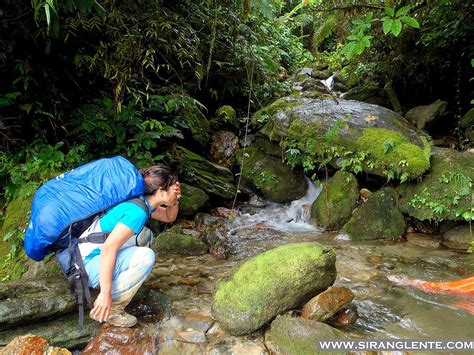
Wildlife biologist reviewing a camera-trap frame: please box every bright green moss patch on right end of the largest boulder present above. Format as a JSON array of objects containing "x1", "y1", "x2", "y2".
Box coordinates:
[{"x1": 354, "y1": 128, "x2": 431, "y2": 180}]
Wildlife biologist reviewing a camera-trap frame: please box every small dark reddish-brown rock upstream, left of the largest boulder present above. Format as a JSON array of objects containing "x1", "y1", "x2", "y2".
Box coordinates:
[{"x1": 209, "y1": 131, "x2": 239, "y2": 168}]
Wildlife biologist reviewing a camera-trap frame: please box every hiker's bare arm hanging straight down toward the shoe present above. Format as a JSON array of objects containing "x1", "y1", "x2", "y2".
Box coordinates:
[{"x1": 90, "y1": 222, "x2": 134, "y2": 322}]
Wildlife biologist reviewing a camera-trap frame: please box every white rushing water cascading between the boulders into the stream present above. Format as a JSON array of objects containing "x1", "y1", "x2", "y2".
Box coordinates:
[{"x1": 230, "y1": 178, "x2": 321, "y2": 233}]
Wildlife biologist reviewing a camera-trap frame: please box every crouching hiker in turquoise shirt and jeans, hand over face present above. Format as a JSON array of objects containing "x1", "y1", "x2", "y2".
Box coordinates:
[{"x1": 79, "y1": 165, "x2": 181, "y2": 327}]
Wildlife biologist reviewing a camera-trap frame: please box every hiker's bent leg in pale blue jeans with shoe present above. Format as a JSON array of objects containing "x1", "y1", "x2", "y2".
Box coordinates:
[{"x1": 85, "y1": 247, "x2": 155, "y2": 327}]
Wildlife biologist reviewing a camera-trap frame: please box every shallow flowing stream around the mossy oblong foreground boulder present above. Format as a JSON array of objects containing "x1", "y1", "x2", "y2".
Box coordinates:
[{"x1": 148, "y1": 179, "x2": 474, "y2": 352}]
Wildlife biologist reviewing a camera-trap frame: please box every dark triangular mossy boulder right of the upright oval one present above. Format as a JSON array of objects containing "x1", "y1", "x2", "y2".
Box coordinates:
[{"x1": 343, "y1": 187, "x2": 406, "y2": 240}]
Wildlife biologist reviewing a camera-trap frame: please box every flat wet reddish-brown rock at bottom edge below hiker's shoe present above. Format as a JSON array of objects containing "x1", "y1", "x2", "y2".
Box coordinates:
[{"x1": 81, "y1": 325, "x2": 157, "y2": 355}]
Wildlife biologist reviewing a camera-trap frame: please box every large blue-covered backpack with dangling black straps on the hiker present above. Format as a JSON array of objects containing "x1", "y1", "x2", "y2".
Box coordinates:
[{"x1": 24, "y1": 156, "x2": 148, "y2": 327}]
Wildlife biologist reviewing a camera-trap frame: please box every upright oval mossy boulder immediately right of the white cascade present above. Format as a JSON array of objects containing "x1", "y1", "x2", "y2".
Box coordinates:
[{"x1": 311, "y1": 170, "x2": 359, "y2": 230}]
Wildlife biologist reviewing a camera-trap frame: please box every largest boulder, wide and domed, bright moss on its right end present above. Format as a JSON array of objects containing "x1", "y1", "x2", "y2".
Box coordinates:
[{"x1": 261, "y1": 97, "x2": 431, "y2": 180}]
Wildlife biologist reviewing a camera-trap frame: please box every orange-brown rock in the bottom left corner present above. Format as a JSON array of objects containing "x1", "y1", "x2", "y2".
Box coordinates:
[{"x1": 0, "y1": 334, "x2": 71, "y2": 355}]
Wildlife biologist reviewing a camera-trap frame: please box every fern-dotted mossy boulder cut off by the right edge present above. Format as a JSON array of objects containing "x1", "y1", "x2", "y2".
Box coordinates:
[{"x1": 399, "y1": 147, "x2": 474, "y2": 221}]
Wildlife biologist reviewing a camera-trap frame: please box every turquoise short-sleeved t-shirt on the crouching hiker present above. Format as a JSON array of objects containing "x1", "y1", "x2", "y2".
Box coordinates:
[{"x1": 99, "y1": 202, "x2": 148, "y2": 234}]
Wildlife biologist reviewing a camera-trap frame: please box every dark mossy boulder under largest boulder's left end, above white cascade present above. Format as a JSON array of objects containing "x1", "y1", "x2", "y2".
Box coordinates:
[{"x1": 237, "y1": 139, "x2": 308, "y2": 202}]
